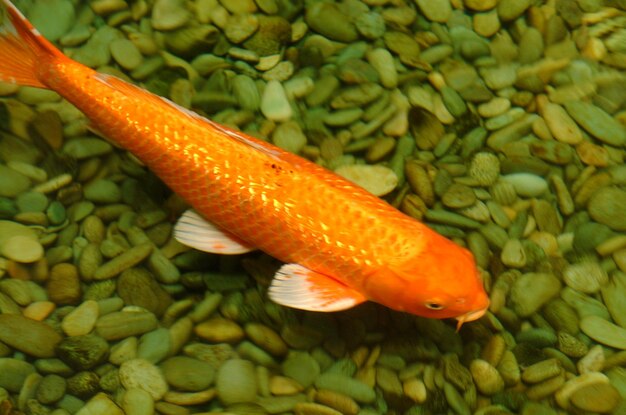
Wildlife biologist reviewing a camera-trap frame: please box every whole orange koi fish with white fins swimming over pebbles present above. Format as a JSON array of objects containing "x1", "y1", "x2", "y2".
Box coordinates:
[{"x1": 0, "y1": 0, "x2": 489, "y2": 326}]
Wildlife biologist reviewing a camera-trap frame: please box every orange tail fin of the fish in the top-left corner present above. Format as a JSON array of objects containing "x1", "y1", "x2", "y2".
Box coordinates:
[{"x1": 0, "y1": 0, "x2": 63, "y2": 88}]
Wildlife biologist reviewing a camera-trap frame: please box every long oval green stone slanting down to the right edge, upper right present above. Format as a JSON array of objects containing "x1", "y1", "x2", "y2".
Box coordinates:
[{"x1": 564, "y1": 101, "x2": 626, "y2": 147}]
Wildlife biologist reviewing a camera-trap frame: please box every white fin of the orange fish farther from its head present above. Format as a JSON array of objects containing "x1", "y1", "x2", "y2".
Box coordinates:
[{"x1": 174, "y1": 209, "x2": 255, "y2": 255}]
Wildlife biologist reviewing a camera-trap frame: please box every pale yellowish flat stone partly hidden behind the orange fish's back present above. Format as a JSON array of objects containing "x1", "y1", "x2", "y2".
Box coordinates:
[{"x1": 335, "y1": 164, "x2": 398, "y2": 196}]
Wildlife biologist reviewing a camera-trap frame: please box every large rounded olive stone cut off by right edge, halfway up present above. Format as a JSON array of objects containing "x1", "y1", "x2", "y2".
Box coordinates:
[{"x1": 587, "y1": 187, "x2": 626, "y2": 231}]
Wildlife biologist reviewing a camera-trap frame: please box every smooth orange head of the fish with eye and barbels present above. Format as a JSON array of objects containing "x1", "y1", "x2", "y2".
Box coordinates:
[{"x1": 368, "y1": 234, "x2": 489, "y2": 327}]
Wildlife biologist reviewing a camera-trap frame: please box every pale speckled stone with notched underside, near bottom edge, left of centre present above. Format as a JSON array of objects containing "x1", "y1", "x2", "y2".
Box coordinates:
[{"x1": 119, "y1": 359, "x2": 169, "y2": 401}]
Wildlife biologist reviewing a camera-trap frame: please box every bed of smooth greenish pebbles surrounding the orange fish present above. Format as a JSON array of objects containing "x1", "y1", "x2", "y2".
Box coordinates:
[{"x1": 0, "y1": 0, "x2": 626, "y2": 415}]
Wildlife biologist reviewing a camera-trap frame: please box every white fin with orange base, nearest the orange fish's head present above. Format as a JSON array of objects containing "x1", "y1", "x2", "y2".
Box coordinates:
[{"x1": 269, "y1": 264, "x2": 367, "y2": 312}]
